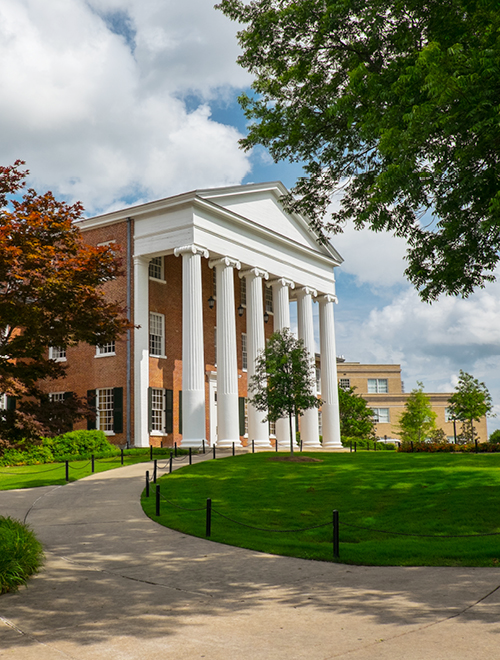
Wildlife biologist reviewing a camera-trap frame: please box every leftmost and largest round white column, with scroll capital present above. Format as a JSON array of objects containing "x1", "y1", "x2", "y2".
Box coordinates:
[{"x1": 174, "y1": 245, "x2": 208, "y2": 447}]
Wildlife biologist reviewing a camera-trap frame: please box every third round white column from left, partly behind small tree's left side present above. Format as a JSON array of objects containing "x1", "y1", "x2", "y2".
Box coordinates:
[{"x1": 240, "y1": 268, "x2": 271, "y2": 449}]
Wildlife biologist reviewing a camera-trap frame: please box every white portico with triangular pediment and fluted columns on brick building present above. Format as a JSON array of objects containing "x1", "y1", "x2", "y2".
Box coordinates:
[{"x1": 89, "y1": 182, "x2": 342, "y2": 449}]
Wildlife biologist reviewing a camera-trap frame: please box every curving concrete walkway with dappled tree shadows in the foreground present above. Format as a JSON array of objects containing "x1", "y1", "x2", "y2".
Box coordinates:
[{"x1": 0, "y1": 454, "x2": 500, "y2": 660}]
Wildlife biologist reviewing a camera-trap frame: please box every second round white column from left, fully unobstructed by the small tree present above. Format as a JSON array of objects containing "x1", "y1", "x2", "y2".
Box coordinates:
[{"x1": 209, "y1": 257, "x2": 241, "y2": 447}]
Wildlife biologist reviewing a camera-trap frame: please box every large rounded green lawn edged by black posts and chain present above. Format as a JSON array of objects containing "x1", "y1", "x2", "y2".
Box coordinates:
[{"x1": 142, "y1": 452, "x2": 500, "y2": 567}]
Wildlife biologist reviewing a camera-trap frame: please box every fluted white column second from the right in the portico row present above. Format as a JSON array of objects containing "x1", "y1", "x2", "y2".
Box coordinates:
[{"x1": 297, "y1": 287, "x2": 321, "y2": 449}]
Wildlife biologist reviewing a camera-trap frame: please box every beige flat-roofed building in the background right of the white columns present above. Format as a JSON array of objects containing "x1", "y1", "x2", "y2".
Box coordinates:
[{"x1": 337, "y1": 358, "x2": 488, "y2": 442}]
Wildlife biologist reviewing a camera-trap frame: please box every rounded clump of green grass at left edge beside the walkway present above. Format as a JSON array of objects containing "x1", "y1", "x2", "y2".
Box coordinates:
[{"x1": 0, "y1": 516, "x2": 43, "y2": 594}]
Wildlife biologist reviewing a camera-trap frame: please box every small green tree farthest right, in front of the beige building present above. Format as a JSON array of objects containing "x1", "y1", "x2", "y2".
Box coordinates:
[{"x1": 448, "y1": 369, "x2": 493, "y2": 442}]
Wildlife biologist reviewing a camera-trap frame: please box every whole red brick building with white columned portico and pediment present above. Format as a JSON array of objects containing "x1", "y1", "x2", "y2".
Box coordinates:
[{"x1": 50, "y1": 183, "x2": 342, "y2": 449}]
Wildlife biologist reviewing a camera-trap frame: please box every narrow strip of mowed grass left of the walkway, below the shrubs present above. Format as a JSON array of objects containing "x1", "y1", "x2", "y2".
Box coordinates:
[{"x1": 0, "y1": 451, "x2": 154, "y2": 490}]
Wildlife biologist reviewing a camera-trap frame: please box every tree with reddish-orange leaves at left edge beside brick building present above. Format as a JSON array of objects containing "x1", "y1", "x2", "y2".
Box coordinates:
[{"x1": 0, "y1": 161, "x2": 127, "y2": 445}]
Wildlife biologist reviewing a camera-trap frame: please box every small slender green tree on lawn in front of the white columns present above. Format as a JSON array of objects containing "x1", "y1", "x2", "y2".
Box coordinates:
[{"x1": 249, "y1": 328, "x2": 321, "y2": 454}]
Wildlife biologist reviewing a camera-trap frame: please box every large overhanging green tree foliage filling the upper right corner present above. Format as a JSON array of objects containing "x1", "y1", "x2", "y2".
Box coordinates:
[{"x1": 218, "y1": 0, "x2": 500, "y2": 300}]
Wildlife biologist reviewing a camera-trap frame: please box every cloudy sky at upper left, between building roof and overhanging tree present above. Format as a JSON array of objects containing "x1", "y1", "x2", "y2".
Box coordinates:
[{"x1": 0, "y1": 0, "x2": 250, "y2": 212}]
